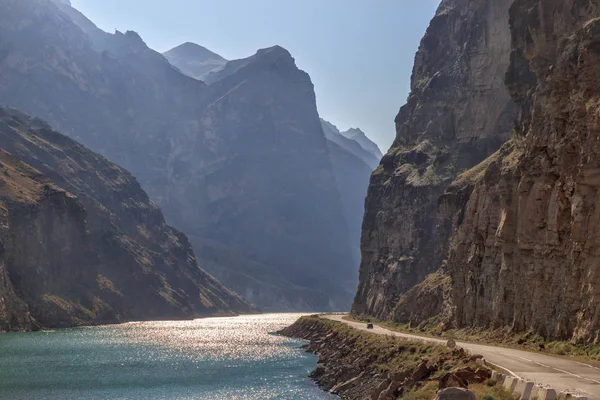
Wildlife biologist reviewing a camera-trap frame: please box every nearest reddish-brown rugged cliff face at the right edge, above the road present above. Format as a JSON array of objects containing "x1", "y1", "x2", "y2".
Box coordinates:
[{"x1": 448, "y1": 0, "x2": 600, "y2": 342}]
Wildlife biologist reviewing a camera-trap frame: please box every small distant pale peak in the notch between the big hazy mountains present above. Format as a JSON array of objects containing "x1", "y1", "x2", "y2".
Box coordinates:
[{"x1": 163, "y1": 42, "x2": 227, "y2": 79}]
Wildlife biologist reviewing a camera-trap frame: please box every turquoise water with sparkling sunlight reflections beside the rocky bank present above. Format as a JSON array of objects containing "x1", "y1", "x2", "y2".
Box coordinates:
[{"x1": 0, "y1": 314, "x2": 335, "y2": 400}]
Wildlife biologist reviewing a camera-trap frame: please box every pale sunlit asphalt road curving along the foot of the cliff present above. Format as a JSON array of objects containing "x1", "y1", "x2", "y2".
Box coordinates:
[{"x1": 325, "y1": 315, "x2": 600, "y2": 399}]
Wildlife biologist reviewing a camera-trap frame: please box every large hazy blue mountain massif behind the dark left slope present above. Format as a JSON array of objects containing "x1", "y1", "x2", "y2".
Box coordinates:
[{"x1": 0, "y1": 0, "x2": 356, "y2": 310}]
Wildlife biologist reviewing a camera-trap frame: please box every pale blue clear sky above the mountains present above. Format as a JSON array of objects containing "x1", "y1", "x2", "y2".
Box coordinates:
[{"x1": 71, "y1": 0, "x2": 439, "y2": 153}]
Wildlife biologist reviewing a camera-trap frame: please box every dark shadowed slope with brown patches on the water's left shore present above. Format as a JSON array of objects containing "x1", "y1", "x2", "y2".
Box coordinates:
[{"x1": 0, "y1": 108, "x2": 255, "y2": 330}]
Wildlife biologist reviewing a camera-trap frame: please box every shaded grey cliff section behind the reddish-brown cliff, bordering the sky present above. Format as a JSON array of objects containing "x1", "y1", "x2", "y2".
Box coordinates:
[{"x1": 353, "y1": 0, "x2": 515, "y2": 318}]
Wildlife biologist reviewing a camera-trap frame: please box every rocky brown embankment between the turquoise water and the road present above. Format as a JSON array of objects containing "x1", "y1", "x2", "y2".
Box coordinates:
[{"x1": 279, "y1": 316, "x2": 512, "y2": 400}]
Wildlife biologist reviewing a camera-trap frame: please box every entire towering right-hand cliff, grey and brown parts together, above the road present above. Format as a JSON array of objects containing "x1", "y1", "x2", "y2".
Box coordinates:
[{"x1": 353, "y1": 0, "x2": 600, "y2": 343}]
